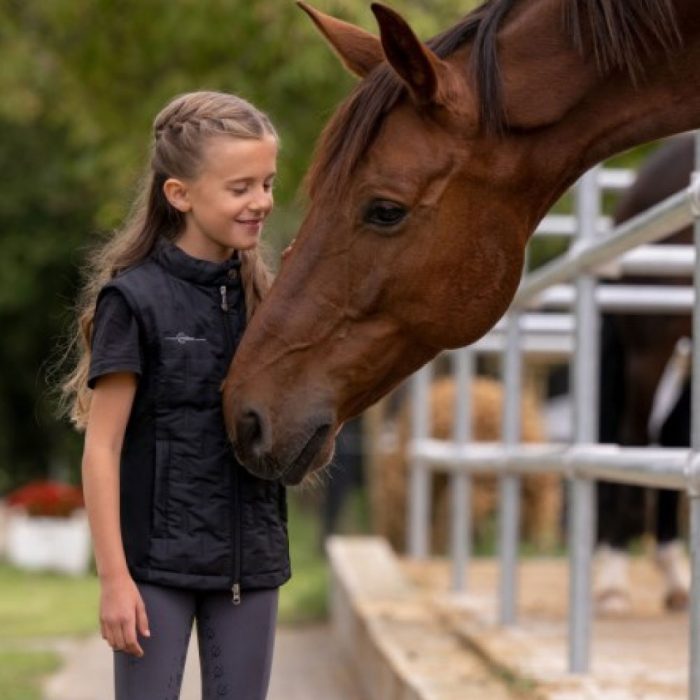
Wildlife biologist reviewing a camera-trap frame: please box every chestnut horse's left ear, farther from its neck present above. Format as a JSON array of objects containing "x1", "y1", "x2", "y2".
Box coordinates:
[{"x1": 297, "y1": 1, "x2": 384, "y2": 78}]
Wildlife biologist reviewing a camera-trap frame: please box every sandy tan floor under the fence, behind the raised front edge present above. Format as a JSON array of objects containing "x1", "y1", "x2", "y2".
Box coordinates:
[{"x1": 402, "y1": 557, "x2": 689, "y2": 700}]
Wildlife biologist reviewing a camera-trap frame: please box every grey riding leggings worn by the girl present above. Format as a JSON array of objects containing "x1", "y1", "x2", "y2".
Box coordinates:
[{"x1": 114, "y1": 583, "x2": 278, "y2": 700}]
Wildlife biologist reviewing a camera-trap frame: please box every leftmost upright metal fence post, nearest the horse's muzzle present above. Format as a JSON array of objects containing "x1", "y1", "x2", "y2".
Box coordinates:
[{"x1": 406, "y1": 364, "x2": 432, "y2": 559}]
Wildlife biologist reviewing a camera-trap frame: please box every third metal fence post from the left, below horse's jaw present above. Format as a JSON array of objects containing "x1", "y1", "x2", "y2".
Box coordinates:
[{"x1": 499, "y1": 311, "x2": 522, "y2": 625}]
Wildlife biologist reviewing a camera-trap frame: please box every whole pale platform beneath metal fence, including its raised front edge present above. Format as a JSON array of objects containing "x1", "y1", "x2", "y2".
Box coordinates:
[{"x1": 330, "y1": 537, "x2": 689, "y2": 700}]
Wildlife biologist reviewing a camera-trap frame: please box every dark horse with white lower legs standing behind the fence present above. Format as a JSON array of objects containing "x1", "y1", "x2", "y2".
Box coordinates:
[{"x1": 596, "y1": 135, "x2": 695, "y2": 614}]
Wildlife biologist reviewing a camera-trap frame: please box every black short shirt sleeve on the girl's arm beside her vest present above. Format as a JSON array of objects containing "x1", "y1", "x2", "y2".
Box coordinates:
[{"x1": 87, "y1": 290, "x2": 143, "y2": 389}]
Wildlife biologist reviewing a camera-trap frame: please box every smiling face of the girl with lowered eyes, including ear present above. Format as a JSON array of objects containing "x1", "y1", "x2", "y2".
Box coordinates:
[{"x1": 164, "y1": 135, "x2": 277, "y2": 261}]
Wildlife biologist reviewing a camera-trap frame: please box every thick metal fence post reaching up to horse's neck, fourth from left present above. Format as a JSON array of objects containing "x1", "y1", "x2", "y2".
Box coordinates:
[{"x1": 568, "y1": 166, "x2": 600, "y2": 673}]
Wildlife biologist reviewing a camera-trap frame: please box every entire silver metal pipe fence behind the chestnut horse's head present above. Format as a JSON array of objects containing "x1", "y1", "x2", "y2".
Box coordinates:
[{"x1": 408, "y1": 132, "x2": 700, "y2": 700}]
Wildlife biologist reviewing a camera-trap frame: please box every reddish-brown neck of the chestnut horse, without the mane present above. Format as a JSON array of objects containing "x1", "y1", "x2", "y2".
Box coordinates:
[{"x1": 492, "y1": 0, "x2": 700, "y2": 205}]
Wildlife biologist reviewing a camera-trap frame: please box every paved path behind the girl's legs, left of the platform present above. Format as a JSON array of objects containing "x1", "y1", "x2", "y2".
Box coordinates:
[{"x1": 44, "y1": 624, "x2": 364, "y2": 700}]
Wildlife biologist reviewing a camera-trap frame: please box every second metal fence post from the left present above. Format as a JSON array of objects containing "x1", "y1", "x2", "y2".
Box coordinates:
[{"x1": 450, "y1": 348, "x2": 474, "y2": 591}]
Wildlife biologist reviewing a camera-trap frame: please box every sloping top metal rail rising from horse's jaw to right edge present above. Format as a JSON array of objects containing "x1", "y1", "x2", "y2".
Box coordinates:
[{"x1": 513, "y1": 182, "x2": 700, "y2": 308}]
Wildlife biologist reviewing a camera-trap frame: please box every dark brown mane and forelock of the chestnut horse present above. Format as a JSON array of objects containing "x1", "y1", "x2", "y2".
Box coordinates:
[{"x1": 306, "y1": 0, "x2": 680, "y2": 197}]
